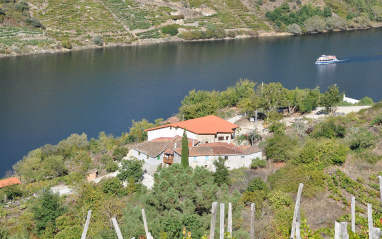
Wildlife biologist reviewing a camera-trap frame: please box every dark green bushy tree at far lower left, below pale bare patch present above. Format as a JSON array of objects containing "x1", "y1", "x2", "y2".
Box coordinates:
[{"x1": 31, "y1": 189, "x2": 66, "y2": 235}]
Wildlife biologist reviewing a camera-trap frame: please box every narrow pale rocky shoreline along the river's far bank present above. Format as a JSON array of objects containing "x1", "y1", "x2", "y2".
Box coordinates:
[{"x1": 0, "y1": 23, "x2": 382, "y2": 59}]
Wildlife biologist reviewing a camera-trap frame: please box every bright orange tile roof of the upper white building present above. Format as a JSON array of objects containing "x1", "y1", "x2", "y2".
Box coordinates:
[{"x1": 146, "y1": 115, "x2": 239, "y2": 135}]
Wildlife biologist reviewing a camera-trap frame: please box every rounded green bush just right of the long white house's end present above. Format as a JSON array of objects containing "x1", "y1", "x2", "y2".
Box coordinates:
[{"x1": 265, "y1": 134, "x2": 297, "y2": 162}]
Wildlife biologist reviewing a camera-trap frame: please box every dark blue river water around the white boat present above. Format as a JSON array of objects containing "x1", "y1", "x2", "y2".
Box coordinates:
[{"x1": 0, "y1": 28, "x2": 382, "y2": 177}]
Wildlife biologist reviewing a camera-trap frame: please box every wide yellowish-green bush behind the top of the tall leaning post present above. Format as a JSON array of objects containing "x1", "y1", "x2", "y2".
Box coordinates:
[{"x1": 268, "y1": 164, "x2": 325, "y2": 197}]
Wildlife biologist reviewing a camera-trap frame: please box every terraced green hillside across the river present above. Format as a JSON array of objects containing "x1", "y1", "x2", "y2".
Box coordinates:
[{"x1": 0, "y1": 0, "x2": 382, "y2": 55}]
